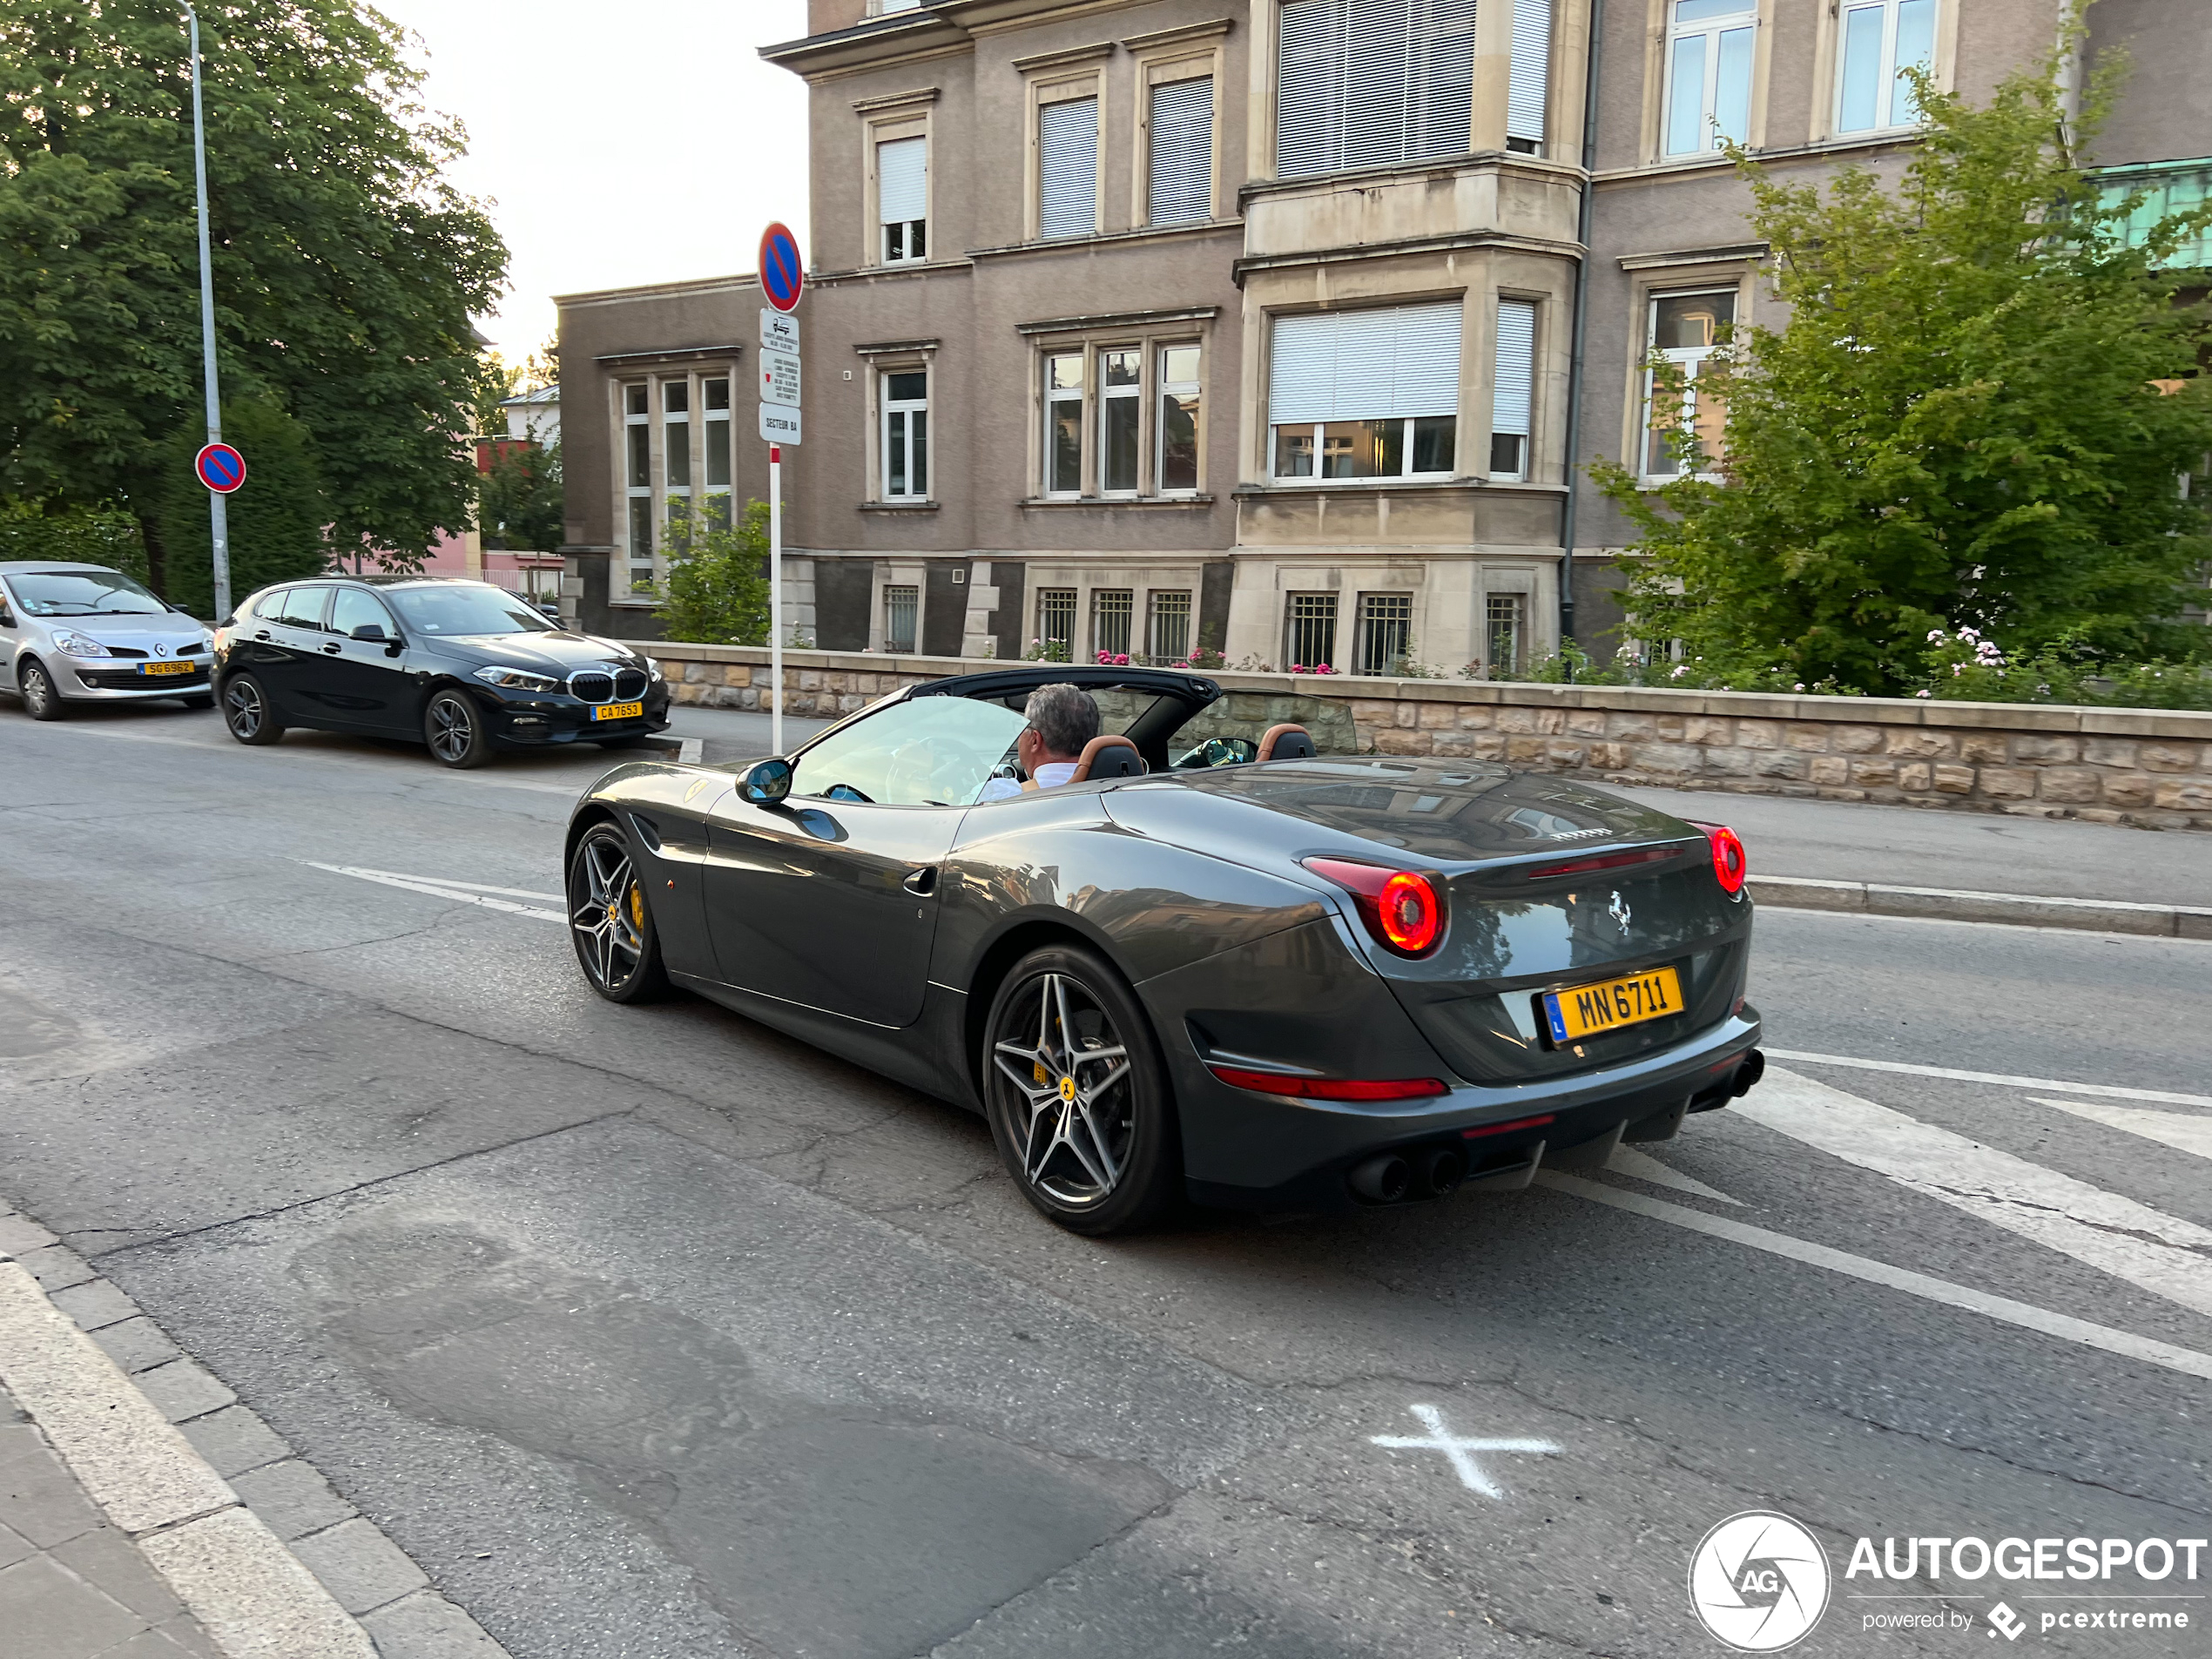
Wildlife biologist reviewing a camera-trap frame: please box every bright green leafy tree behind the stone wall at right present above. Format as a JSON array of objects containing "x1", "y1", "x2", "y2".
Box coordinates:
[{"x1": 1593, "y1": 32, "x2": 2212, "y2": 695}]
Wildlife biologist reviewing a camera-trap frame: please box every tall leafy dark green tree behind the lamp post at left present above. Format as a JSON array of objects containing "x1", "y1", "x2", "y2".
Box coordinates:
[{"x1": 0, "y1": 0, "x2": 507, "y2": 586}]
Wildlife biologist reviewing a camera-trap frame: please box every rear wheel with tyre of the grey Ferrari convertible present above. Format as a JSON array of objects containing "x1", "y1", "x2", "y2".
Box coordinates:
[{"x1": 984, "y1": 945, "x2": 1184, "y2": 1234}]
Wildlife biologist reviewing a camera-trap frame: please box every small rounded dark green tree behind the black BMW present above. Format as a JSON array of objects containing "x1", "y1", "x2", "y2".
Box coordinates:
[{"x1": 155, "y1": 398, "x2": 329, "y2": 619}]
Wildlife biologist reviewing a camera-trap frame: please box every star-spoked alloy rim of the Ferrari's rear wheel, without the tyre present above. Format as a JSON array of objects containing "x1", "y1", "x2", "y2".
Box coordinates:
[{"x1": 991, "y1": 974, "x2": 1135, "y2": 1210}]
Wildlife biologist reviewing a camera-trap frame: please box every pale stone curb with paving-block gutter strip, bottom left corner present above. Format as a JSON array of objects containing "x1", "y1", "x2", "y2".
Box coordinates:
[{"x1": 0, "y1": 1201, "x2": 507, "y2": 1659}]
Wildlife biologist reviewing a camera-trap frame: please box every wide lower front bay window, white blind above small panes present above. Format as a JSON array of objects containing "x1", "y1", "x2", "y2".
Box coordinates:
[{"x1": 1267, "y1": 303, "x2": 1460, "y2": 480}]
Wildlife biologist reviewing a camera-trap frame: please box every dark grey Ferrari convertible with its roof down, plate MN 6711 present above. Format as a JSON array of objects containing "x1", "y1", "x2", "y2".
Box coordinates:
[{"x1": 566, "y1": 664, "x2": 1763, "y2": 1234}]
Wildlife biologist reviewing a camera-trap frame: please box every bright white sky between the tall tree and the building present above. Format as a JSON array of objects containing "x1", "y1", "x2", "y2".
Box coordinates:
[{"x1": 369, "y1": 0, "x2": 807, "y2": 365}]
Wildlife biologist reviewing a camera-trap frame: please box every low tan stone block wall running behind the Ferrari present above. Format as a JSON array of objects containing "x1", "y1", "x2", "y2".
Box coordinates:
[{"x1": 639, "y1": 642, "x2": 2212, "y2": 830}]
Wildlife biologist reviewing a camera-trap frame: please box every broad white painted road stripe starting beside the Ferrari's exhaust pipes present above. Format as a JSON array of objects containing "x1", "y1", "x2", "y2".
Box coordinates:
[{"x1": 1734, "y1": 1066, "x2": 2212, "y2": 1314}]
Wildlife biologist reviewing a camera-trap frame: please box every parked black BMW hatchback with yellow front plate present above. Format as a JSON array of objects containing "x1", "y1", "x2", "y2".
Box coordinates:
[{"x1": 214, "y1": 577, "x2": 668, "y2": 767}]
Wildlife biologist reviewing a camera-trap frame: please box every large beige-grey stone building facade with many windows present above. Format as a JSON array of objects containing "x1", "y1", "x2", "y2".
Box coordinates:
[{"x1": 562, "y1": 0, "x2": 2212, "y2": 675}]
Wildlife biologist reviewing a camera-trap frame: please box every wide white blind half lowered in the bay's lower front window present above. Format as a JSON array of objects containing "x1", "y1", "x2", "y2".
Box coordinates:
[{"x1": 1267, "y1": 303, "x2": 1460, "y2": 427}]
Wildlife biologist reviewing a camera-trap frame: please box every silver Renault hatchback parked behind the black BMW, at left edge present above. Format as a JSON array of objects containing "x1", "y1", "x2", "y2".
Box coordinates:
[{"x1": 0, "y1": 560, "x2": 214, "y2": 721}]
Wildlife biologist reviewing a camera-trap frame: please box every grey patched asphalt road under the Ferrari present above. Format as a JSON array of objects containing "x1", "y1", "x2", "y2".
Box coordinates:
[{"x1": 0, "y1": 705, "x2": 2212, "y2": 1659}]
